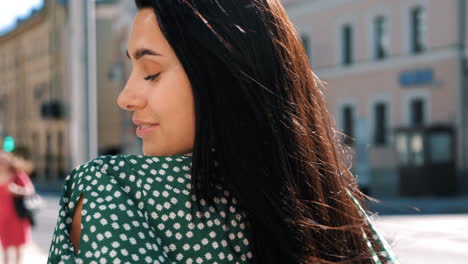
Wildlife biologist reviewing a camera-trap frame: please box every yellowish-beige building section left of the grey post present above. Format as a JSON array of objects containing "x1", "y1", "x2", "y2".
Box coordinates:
[{"x1": 0, "y1": 0, "x2": 69, "y2": 186}]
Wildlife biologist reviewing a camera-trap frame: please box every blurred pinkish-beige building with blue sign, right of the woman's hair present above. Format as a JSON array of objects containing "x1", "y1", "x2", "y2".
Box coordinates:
[{"x1": 283, "y1": 0, "x2": 468, "y2": 196}]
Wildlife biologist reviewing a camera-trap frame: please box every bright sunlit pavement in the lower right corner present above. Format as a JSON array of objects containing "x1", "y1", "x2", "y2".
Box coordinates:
[{"x1": 375, "y1": 214, "x2": 468, "y2": 264}]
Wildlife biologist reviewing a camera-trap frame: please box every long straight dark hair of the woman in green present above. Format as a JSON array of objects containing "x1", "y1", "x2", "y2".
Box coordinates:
[{"x1": 135, "y1": 0, "x2": 383, "y2": 263}]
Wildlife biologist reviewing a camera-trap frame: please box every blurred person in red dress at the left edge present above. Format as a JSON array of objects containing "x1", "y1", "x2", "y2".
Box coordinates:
[{"x1": 0, "y1": 151, "x2": 35, "y2": 264}]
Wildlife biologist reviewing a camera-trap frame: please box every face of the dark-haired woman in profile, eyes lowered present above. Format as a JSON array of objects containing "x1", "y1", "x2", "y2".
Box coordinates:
[{"x1": 117, "y1": 8, "x2": 195, "y2": 156}]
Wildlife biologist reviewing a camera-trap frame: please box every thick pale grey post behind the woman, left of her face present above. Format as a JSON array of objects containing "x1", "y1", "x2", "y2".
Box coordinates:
[{"x1": 68, "y1": 0, "x2": 97, "y2": 166}]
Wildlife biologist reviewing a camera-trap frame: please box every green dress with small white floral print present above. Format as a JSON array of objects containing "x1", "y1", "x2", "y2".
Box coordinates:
[{"x1": 48, "y1": 155, "x2": 396, "y2": 264}]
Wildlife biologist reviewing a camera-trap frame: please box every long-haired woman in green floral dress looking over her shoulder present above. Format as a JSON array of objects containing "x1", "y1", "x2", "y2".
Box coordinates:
[{"x1": 49, "y1": 0, "x2": 396, "y2": 263}]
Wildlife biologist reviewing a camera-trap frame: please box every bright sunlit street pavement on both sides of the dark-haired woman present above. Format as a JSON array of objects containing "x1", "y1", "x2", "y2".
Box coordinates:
[{"x1": 0, "y1": 195, "x2": 468, "y2": 264}]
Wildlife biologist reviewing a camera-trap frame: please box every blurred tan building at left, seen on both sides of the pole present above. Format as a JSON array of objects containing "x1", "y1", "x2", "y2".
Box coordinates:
[{"x1": 0, "y1": 0, "x2": 139, "y2": 190}]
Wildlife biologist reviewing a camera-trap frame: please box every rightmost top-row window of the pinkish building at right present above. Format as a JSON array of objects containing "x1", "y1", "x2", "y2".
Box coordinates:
[{"x1": 410, "y1": 6, "x2": 426, "y2": 54}]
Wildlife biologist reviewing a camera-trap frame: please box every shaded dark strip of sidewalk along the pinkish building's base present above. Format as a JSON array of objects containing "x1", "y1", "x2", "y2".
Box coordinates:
[{"x1": 368, "y1": 196, "x2": 468, "y2": 215}]
